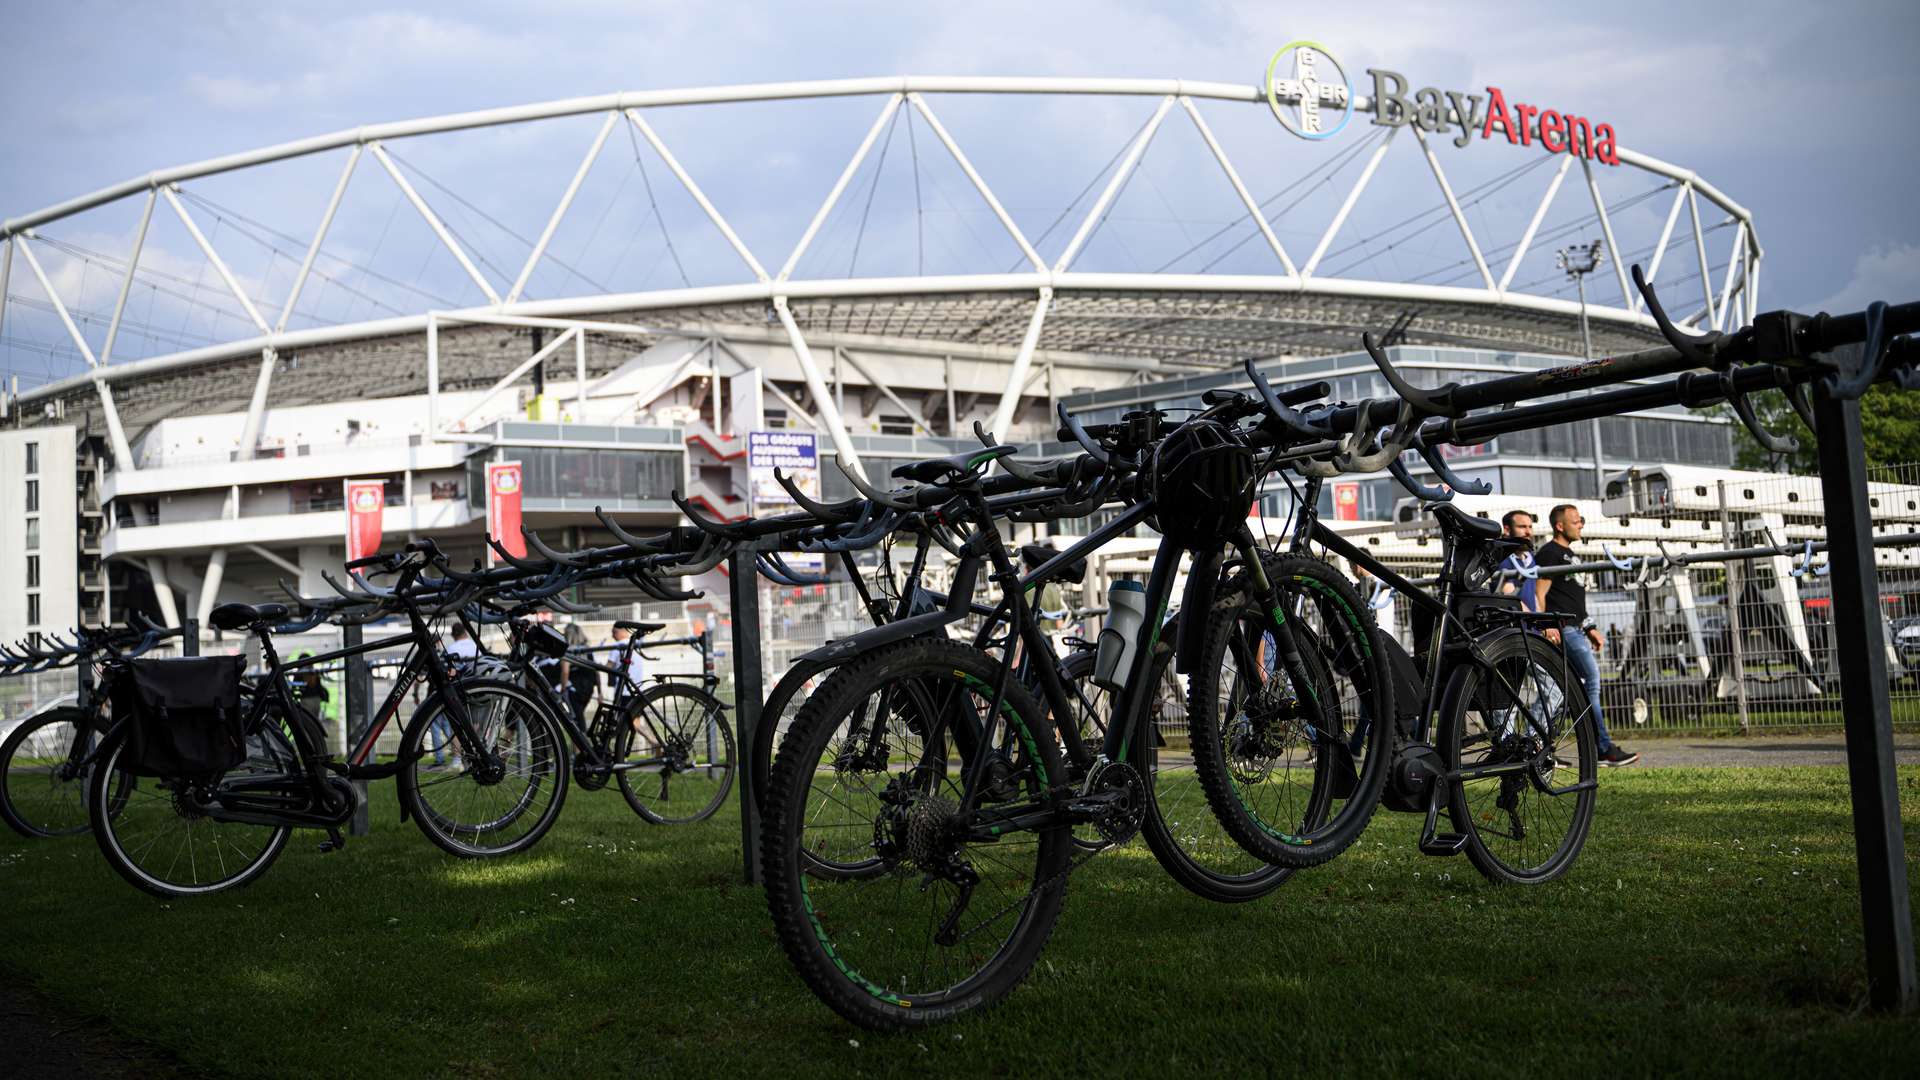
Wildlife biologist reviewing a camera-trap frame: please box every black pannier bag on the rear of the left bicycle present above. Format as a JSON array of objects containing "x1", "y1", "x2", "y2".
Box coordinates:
[{"x1": 113, "y1": 655, "x2": 246, "y2": 776}]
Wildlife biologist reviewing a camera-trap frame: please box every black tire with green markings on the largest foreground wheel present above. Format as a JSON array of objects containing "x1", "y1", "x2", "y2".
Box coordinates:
[{"x1": 760, "y1": 638, "x2": 1071, "y2": 1030}]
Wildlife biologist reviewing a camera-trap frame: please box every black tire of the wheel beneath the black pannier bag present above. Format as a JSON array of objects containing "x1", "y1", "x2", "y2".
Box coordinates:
[{"x1": 86, "y1": 724, "x2": 300, "y2": 899}]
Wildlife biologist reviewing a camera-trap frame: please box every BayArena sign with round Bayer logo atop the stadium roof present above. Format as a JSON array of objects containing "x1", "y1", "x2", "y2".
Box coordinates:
[{"x1": 1265, "y1": 40, "x2": 1620, "y2": 165}]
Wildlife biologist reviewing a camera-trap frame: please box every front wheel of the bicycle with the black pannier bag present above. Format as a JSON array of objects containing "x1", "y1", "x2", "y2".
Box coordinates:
[{"x1": 399, "y1": 678, "x2": 568, "y2": 859}]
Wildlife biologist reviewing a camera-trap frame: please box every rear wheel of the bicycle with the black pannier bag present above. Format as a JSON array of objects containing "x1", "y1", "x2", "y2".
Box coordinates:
[{"x1": 86, "y1": 723, "x2": 293, "y2": 899}]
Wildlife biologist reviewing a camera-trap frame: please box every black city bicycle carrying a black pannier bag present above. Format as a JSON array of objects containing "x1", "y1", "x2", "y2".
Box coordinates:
[{"x1": 86, "y1": 540, "x2": 566, "y2": 897}]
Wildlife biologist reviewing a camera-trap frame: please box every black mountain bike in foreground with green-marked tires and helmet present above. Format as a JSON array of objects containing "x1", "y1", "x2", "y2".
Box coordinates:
[{"x1": 762, "y1": 394, "x2": 1390, "y2": 1028}]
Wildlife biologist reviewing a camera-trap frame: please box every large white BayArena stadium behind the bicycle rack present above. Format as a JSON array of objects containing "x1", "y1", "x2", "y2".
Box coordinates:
[{"x1": 0, "y1": 54, "x2": 1763, "y2": 638}]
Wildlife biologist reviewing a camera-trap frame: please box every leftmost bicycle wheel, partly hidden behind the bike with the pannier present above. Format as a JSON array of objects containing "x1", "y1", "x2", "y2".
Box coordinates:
[{"x1": 0, "y1": 709, "x2": 127, "y2": 840}]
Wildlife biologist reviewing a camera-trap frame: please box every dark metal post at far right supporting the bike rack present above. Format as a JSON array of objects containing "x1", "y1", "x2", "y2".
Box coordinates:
[{"x1": 1812, "y1": 386, "x2": 1920, "y2": 1013}]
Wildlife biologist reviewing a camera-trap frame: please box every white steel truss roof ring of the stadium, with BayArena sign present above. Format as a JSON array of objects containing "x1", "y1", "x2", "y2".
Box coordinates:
[{"x1": 0, "y1": 56, "x2": 1761, "y2": 455}]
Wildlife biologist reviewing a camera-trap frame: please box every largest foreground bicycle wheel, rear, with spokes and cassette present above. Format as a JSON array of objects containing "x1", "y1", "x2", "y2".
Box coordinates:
[{"x1": 760, "y1": 638, "x2": 1073, "y2": 1030}]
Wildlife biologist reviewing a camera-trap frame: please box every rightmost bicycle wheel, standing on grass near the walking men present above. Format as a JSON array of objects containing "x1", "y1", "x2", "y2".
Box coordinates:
[{"x1": 1440, "y1": 632, "x2": 1599, "y2": 884}]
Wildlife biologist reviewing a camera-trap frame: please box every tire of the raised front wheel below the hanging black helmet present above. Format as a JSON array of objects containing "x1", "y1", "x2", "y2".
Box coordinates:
[{"x1": 1187, "y1": 555, "x2": 1394, "y2": 869}]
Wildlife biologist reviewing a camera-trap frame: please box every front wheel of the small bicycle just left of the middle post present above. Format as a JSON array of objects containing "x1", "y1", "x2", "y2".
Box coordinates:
[{"x1": 614, "y1": 682, "x2": 733, "y2": 824}]
